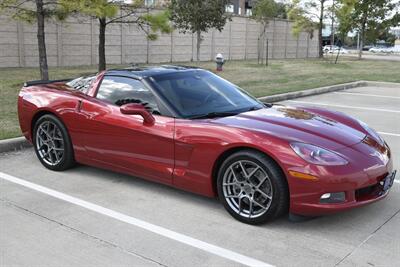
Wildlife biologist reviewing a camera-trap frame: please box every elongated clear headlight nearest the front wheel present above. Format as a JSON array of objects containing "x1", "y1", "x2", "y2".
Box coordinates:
[{"x1": 290, "y1": 142, "x2": 348, "y2": 166}]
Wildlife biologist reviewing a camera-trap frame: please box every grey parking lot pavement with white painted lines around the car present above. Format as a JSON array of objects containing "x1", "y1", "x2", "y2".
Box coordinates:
[{"x1": 0, "y1": 87, "x2": 400, "y2": 266}]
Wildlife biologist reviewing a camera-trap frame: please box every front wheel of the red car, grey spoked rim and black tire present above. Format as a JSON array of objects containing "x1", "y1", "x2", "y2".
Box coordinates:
[{"x1": 217, "y1": 150, "x2": 289, "y2": 224}]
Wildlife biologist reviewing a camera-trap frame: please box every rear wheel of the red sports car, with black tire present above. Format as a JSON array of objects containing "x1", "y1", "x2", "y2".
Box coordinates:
[{"x1": 32, "y1": 114, "x2": 75, "y2": 171}]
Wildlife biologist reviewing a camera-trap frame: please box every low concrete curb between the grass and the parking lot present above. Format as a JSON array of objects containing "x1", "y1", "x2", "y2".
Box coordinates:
[{"x1": 0, "y1": 81, "x2": 400, "y2": 153}]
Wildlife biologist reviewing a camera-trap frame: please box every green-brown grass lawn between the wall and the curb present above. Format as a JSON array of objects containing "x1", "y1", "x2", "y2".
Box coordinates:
[{"x1": 0, "y1": 59, "x2": 400, "y2": 139}]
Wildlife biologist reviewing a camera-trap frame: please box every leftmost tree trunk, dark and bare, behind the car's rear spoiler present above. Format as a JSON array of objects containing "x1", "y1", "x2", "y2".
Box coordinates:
[{"x1": 36, "y1": 0, "x2": 49, "y2": 80}]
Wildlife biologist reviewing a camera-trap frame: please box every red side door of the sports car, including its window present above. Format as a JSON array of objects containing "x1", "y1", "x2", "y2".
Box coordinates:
[{"x1": 80, "y1": 75, "x2": 174, "y2": 183}]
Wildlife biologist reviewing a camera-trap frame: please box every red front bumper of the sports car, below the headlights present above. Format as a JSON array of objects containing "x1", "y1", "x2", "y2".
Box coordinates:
[{"x1": 287, "y1": 140, "x2": 396, "y2": 216}]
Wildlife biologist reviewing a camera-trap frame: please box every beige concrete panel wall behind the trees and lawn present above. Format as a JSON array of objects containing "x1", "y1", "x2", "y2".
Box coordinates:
[{"x1": 0, "y1": 14, "x2": 318, "y2": 67}]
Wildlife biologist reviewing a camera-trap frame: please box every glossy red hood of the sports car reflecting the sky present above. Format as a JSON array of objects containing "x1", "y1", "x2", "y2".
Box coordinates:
[{"x1": 210, "y1": 105, "x2": 365, "y2": 150}]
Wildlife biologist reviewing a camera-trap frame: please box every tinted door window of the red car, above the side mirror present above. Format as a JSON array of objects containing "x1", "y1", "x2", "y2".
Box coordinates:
[{"x1": 97, "y1": 76, "x2": 160, "y2": 114}]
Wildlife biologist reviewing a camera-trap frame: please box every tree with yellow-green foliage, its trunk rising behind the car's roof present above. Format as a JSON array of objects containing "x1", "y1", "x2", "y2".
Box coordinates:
[{"x1": 60, "y1": 0, "x2": 171, "y2": 71}]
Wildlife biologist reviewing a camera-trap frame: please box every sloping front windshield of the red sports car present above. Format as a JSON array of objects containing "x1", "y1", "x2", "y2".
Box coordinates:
[{"x1": 151, "y1": 70, "x2": 263, "y2": 118}]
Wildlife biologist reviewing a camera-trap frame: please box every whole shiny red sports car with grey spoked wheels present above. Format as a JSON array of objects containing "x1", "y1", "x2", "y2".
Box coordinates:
[{"x1": 18, "y1": 66, "x2": 395, "y2": 224}]
